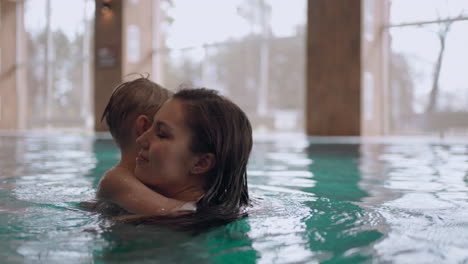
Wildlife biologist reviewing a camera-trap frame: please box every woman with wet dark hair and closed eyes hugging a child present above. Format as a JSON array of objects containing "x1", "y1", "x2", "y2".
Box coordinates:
[{"x1": 127, "y1": 89, "x2": 252, "y2": 230}]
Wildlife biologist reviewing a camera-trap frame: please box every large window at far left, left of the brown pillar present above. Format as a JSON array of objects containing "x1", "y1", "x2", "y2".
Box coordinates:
[{"x1": 23, "y1": 0, "x2": 94, "y2": 129}]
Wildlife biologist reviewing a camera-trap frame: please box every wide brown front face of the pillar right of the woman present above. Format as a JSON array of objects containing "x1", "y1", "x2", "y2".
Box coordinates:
[{"x1": 306, "y1": 0, "x2": 361, "y2": 136}]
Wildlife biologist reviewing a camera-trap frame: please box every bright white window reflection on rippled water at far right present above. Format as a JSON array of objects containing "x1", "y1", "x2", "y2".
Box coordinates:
[{"x1": 373, "y1": 144, "x2": 468, "y2": 263}]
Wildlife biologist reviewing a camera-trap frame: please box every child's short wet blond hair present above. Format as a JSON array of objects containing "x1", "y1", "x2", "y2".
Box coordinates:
[{"x1": 101, "y1": 77, "x2": 171, "y2": 149}]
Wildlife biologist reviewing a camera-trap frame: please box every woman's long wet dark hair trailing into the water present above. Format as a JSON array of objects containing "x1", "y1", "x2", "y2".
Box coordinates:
[{"x1": 122, "y1": 88, "x2": 252, "y2": 233}]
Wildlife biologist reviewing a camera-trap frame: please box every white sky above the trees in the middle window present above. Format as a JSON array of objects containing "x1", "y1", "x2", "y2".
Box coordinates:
[{"x1": 168, "y1": 0, "x2": 307, "y2": 48}]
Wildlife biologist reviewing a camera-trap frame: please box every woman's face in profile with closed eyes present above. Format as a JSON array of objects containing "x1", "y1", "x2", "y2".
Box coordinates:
[{"x1": 135, "y1": 99, "x2": 200, "y2": 196}]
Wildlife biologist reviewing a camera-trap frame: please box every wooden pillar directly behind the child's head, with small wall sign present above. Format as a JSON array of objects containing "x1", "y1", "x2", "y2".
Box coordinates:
[{"x1": 94, "y1": 0, "x2": 154, "y2": 131}]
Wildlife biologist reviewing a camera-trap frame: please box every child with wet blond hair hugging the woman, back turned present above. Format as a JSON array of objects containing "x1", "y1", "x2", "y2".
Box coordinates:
[{"x1": 96, "y1": 78, "x2": 185, "y2": 215}]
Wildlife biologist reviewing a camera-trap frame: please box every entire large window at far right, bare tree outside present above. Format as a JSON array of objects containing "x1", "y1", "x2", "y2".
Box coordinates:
[{"x1": 387, "y1": 0, "x2": 468, "y2": 135}]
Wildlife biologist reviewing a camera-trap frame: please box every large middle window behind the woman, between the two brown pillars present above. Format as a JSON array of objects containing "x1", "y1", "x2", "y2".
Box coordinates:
[{"x1": 154, "y1": 0, "x2": 306, "y2": 131}]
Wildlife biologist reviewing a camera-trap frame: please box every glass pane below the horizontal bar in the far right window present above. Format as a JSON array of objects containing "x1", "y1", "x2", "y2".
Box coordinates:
[{"x1": 390, "y1": 21, "x2": 468, "y2": 134}]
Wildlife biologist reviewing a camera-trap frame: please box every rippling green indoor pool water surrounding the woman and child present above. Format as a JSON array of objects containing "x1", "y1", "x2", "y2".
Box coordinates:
[{"x1": 0, "y1": 134, "x2": 468, "y2": 263}]
